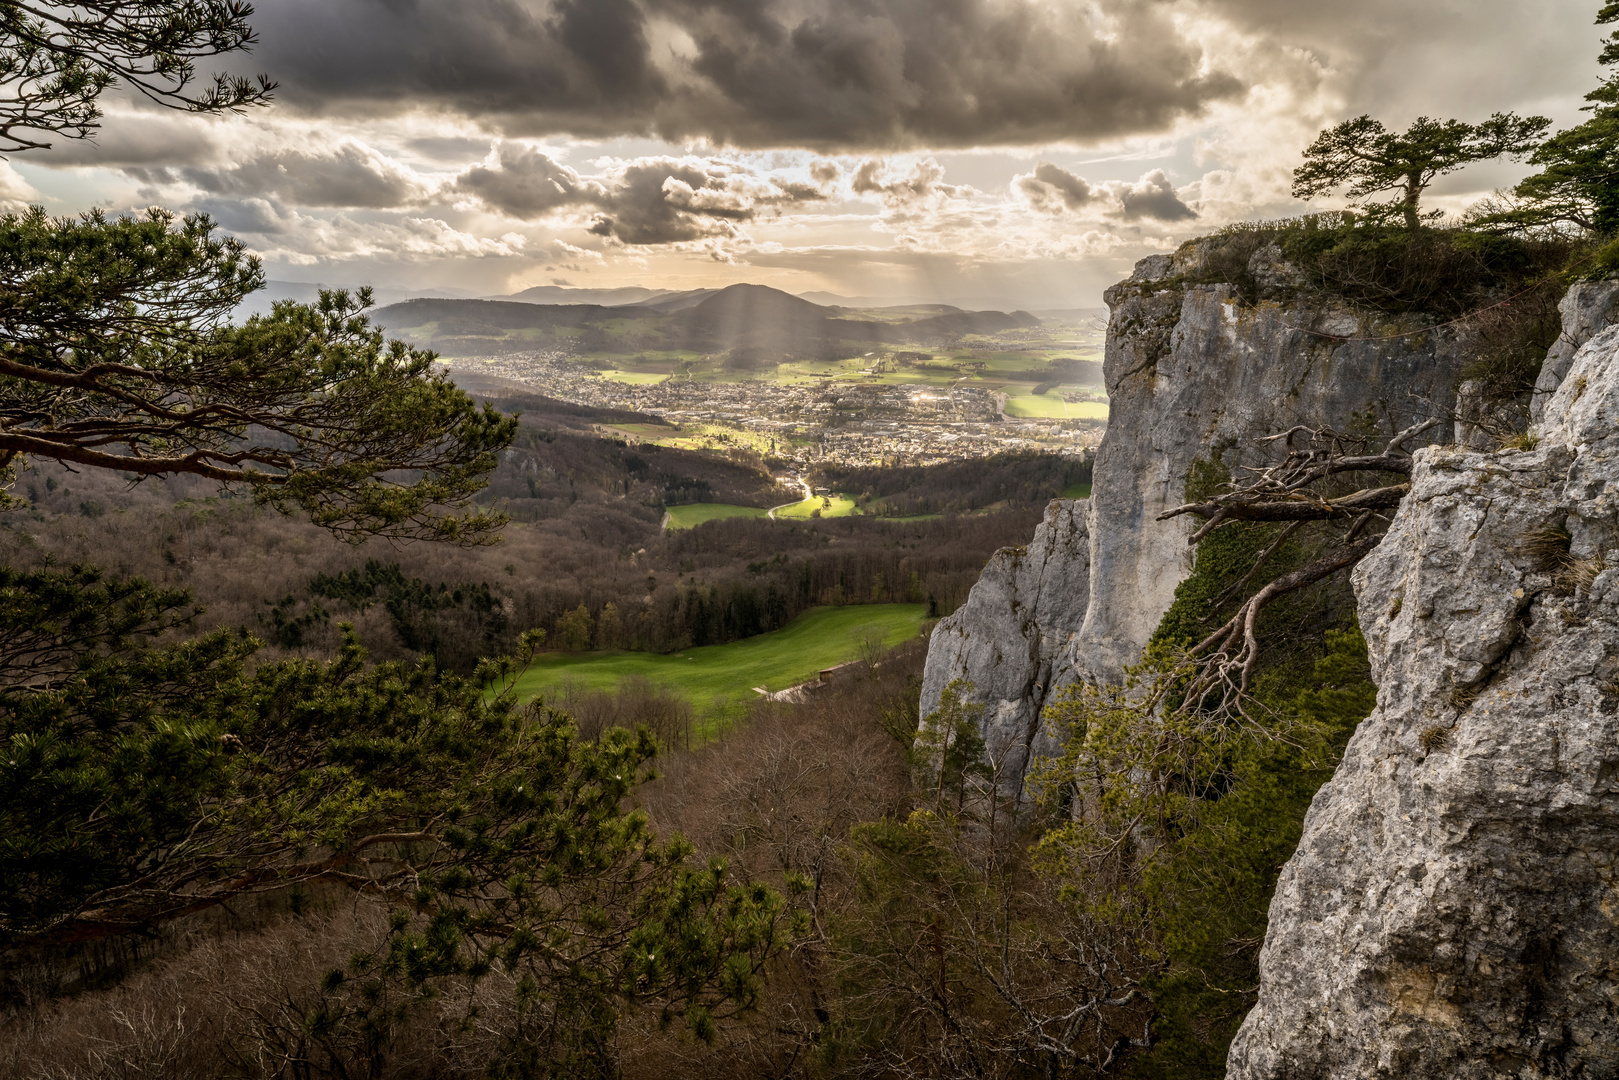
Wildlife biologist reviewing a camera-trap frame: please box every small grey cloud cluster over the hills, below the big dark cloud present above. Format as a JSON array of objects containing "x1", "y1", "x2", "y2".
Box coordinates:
[{"x1": 453, "y1": 142, "x2": 835, "y2": 244}]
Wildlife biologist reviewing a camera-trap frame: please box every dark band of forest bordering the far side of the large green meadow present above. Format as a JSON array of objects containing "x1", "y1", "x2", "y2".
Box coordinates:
[{"x1": 237, "y1": 510, "x2": 1038, "y2": 672}]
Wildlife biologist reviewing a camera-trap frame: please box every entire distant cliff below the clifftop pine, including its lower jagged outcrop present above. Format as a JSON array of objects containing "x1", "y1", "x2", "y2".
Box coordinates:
[{"x1": 921, "y1": 243, "x2": 1464, "y2": 793}]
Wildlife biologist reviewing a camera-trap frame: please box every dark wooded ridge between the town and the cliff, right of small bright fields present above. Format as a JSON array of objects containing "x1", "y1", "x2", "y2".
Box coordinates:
[{"x1": 811, "y1": 452, "x2": 1091, "y2": 517}]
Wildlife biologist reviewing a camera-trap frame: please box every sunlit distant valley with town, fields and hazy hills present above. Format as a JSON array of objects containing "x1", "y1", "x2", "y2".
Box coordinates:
[{"x1": 376, "y1": 285, "x2": 1107, "y2": 471}]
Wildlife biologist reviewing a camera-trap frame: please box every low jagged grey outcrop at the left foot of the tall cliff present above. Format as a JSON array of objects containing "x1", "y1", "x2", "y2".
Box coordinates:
[{"x1": 921, "y1": 499, "x2": 1090, "y2": 792}]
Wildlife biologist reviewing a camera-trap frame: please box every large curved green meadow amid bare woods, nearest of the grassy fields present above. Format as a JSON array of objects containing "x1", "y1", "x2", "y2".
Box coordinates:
[{"x1": 518, "y1": 604, "x2": 928, "y2": 716}]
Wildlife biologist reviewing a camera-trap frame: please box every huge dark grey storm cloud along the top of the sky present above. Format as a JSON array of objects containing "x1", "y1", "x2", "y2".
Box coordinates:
[{"x1": 253, "y1": 0, "x2": 1243, "y2": 149}]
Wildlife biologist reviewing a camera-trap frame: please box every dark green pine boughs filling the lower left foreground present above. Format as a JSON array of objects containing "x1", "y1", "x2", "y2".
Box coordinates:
[{"x1": 0, "y1": 568, "x2": 792, "y2": 1077}]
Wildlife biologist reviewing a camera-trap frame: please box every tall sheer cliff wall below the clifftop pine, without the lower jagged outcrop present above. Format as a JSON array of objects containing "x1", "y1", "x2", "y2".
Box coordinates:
[{"x1": 1075, "y1": 244, "x2": 1465, "y2": 682}]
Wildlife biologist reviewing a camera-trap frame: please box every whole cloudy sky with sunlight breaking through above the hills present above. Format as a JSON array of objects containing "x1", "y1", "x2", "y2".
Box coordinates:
[{"x1": 0, "y1": 0, "x2": 1603, "y2": 309}]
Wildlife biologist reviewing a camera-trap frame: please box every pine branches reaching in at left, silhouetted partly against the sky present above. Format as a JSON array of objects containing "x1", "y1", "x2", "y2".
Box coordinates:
[{"x1": 0, "y1": 209, "x2": 516, "y2": 541}]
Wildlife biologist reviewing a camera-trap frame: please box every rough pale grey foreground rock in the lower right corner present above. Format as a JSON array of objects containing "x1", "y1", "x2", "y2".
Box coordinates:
[{"x1": 1229, "y1": 323, "x2": 1619, "y2": 1080}]
